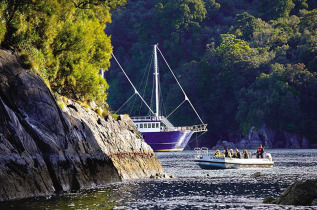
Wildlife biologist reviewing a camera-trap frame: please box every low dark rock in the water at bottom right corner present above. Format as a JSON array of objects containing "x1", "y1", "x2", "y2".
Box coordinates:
[{"x1": 263, "y1": 179, "x2": 317, "y2": 206}]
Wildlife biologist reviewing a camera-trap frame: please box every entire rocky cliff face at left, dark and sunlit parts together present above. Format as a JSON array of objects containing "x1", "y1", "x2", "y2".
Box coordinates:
[{"x1": 0, "y1": 50, "x2": 162, "y2": 201}]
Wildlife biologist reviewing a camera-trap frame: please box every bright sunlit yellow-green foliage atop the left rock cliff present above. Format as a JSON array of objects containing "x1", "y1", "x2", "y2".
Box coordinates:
[{"x1": 0, "y1": 0, "x2": 125, "y2": 105}]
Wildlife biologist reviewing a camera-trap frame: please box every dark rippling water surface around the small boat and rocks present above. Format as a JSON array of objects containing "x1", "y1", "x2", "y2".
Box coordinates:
[{"x1": 0, "y1": 149, "x2": 317, "y2": 209}]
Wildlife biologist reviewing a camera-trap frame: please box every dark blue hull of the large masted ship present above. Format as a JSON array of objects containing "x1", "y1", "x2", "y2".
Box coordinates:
[{"x1": 142, "y1": 131, "x2": 193, "y2": 152}]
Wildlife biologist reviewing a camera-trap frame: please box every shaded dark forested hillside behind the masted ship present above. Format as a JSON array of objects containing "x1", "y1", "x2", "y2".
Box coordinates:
[{"x1": 105, "y1": 0, "x2": 317, "y2": 146}]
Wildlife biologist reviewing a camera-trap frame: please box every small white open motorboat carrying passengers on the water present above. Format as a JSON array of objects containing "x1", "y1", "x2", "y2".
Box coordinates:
[{"x1": 195, "y1": 147, "x2": 274, "y2": 169}]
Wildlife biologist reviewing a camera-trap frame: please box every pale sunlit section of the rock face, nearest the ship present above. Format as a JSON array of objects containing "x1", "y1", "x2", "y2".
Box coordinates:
[{"x1": 65, "y1": 100, "x2": 163, "y2": 179}]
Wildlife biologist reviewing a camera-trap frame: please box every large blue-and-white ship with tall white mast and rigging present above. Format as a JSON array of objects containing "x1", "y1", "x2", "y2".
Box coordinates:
[{"x1": 112, "y1": 44, "x2": 207, "y2": 152}]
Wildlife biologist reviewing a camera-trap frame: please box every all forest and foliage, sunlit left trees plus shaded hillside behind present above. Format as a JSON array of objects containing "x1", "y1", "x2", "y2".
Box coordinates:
[{"x1": 0, "y1": 0, "x2": 317, "y2": 145}]
